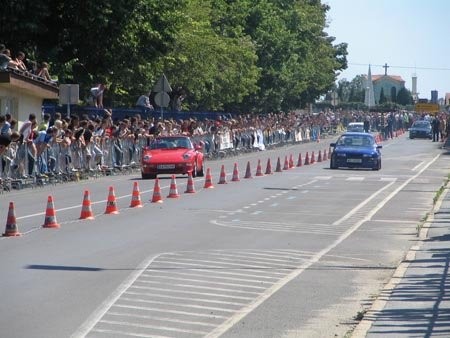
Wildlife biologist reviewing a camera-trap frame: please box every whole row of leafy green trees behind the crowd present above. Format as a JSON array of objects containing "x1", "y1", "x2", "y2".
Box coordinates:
[{"x1": 0, "y1": 0, "x2": 347, "y2": 112}]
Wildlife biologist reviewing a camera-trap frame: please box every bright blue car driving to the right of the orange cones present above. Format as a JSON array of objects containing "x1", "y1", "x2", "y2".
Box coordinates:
[{"x1": 330, "y1": 132, "x2": 382, "y2": 170}]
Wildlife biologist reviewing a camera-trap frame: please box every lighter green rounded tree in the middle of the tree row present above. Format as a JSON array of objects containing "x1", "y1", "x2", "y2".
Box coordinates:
[{"x1": 165, "y1": 0, "x2": 260, "y2": 110}]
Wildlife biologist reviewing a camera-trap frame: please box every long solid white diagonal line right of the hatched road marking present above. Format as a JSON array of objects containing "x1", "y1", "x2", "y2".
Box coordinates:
[{"x1": 206, "y1": 154, "x2": 440, "y2": 338}]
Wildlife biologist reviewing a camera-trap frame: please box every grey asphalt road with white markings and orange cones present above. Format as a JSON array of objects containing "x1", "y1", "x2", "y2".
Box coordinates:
[{"x1": 0, "y1": 135, "x2": 448, "y2": 338}]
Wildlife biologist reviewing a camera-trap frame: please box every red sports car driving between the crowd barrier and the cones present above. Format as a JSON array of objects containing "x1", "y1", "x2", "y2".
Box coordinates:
[{"x1": 141, "y1": 135, "x2": 204, "y2": 179}]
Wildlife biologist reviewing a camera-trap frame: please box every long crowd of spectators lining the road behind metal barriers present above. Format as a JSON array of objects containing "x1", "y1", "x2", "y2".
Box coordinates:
[{"x1": 0, "y1": 105, "x2": 449, "y2": 186}]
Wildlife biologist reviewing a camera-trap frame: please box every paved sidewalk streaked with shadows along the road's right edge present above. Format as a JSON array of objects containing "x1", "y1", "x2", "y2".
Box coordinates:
[{"x1": 352, "y1": 187, "x2": 450, "y2": 338}]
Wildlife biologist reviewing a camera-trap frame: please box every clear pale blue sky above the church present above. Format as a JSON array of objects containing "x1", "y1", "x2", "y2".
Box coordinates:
[{"x1": 322, "y1": 0, "x2": 450, "y2": 99}]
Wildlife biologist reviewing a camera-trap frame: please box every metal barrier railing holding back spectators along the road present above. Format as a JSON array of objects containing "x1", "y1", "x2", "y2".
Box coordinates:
[{"x1": 0, "y1": 126, "x2": 336, "y2": 191}]
